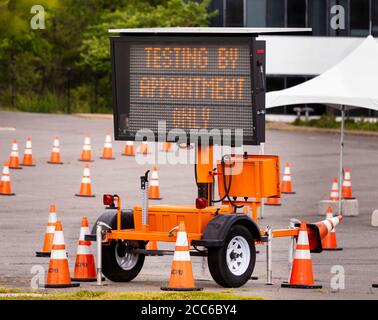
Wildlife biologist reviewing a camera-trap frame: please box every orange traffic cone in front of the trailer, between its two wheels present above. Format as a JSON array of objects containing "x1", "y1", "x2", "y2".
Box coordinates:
[{"x1": 161, "y1": 221, "x2": 203, "y2": 291}]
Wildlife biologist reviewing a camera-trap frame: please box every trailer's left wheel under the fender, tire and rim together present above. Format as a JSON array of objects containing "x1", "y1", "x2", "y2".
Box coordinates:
[{"x1": 102, "y1": 240, "x2": 145, "y2": 282}]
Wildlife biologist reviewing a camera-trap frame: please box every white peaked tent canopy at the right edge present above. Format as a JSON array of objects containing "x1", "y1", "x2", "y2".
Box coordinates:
[{"x1": 266, "y1": 36, "x2": 378, "y2": 110}]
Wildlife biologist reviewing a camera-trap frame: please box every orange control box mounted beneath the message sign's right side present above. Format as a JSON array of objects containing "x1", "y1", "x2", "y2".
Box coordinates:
[{"x1": 217, "y1": 155, "x2": 281, "y2": 200}]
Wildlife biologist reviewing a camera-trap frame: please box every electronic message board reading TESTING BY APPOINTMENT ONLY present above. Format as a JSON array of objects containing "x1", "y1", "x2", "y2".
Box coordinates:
[{"x1": 111, "y1": 34, "x2": 265, "y2": 144}]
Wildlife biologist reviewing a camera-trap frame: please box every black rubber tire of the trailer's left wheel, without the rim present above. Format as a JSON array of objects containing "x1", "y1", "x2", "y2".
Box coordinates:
[{"x1": 102, "y1": 241, "x2": 145, "y2": 282}]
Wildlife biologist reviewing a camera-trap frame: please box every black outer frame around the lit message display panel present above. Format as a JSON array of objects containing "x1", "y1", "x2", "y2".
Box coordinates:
[{"x1": 110, "y1": 33, "x2": 266, "y2": 146}]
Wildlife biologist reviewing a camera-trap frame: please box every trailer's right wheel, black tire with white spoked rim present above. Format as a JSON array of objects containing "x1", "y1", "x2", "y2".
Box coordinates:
[{"x1": 208, "y1": 224, "x2": 256, "y2": 288}]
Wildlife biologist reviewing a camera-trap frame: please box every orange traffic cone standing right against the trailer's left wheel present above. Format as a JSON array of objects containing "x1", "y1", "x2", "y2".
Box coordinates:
[{"x1": 71, "y1": 216, "x2": 97, "y2": 282}]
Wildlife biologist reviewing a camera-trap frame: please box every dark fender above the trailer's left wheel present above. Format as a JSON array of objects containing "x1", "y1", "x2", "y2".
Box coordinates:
[{"x1": 85, "y1": 209, "x2": 134, "y2": 241}]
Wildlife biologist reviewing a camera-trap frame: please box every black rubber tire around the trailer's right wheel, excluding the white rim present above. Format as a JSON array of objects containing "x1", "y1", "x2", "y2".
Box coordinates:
[{"x1": 208, "y1": 224, "x2": 256, "y2": 288}]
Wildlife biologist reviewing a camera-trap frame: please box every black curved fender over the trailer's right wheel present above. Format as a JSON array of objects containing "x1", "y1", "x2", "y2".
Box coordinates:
[{"x1": 192, "y1": 213, "x2": 261, "y2": 247}]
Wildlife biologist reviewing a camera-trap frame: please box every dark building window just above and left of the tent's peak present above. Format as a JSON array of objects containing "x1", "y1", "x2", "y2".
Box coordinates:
[{"x1": 350, "y1": 0, "x2": 369, "y2": 37}]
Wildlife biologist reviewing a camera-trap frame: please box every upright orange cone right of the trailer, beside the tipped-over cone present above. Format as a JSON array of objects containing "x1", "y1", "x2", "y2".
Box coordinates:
[{"x1": 281, "y1": 221, "x2": 322, "y2": 289}]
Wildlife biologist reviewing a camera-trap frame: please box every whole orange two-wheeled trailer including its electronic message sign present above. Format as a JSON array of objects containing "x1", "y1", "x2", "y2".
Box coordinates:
[{"x1": 87, "y1": 28, "x2": 321, "y2": 287}]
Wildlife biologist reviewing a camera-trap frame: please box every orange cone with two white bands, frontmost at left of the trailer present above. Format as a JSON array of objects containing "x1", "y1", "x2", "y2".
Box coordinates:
[{"x1": 45, "y1": 221, "x2": 80, "y2": 288}]
